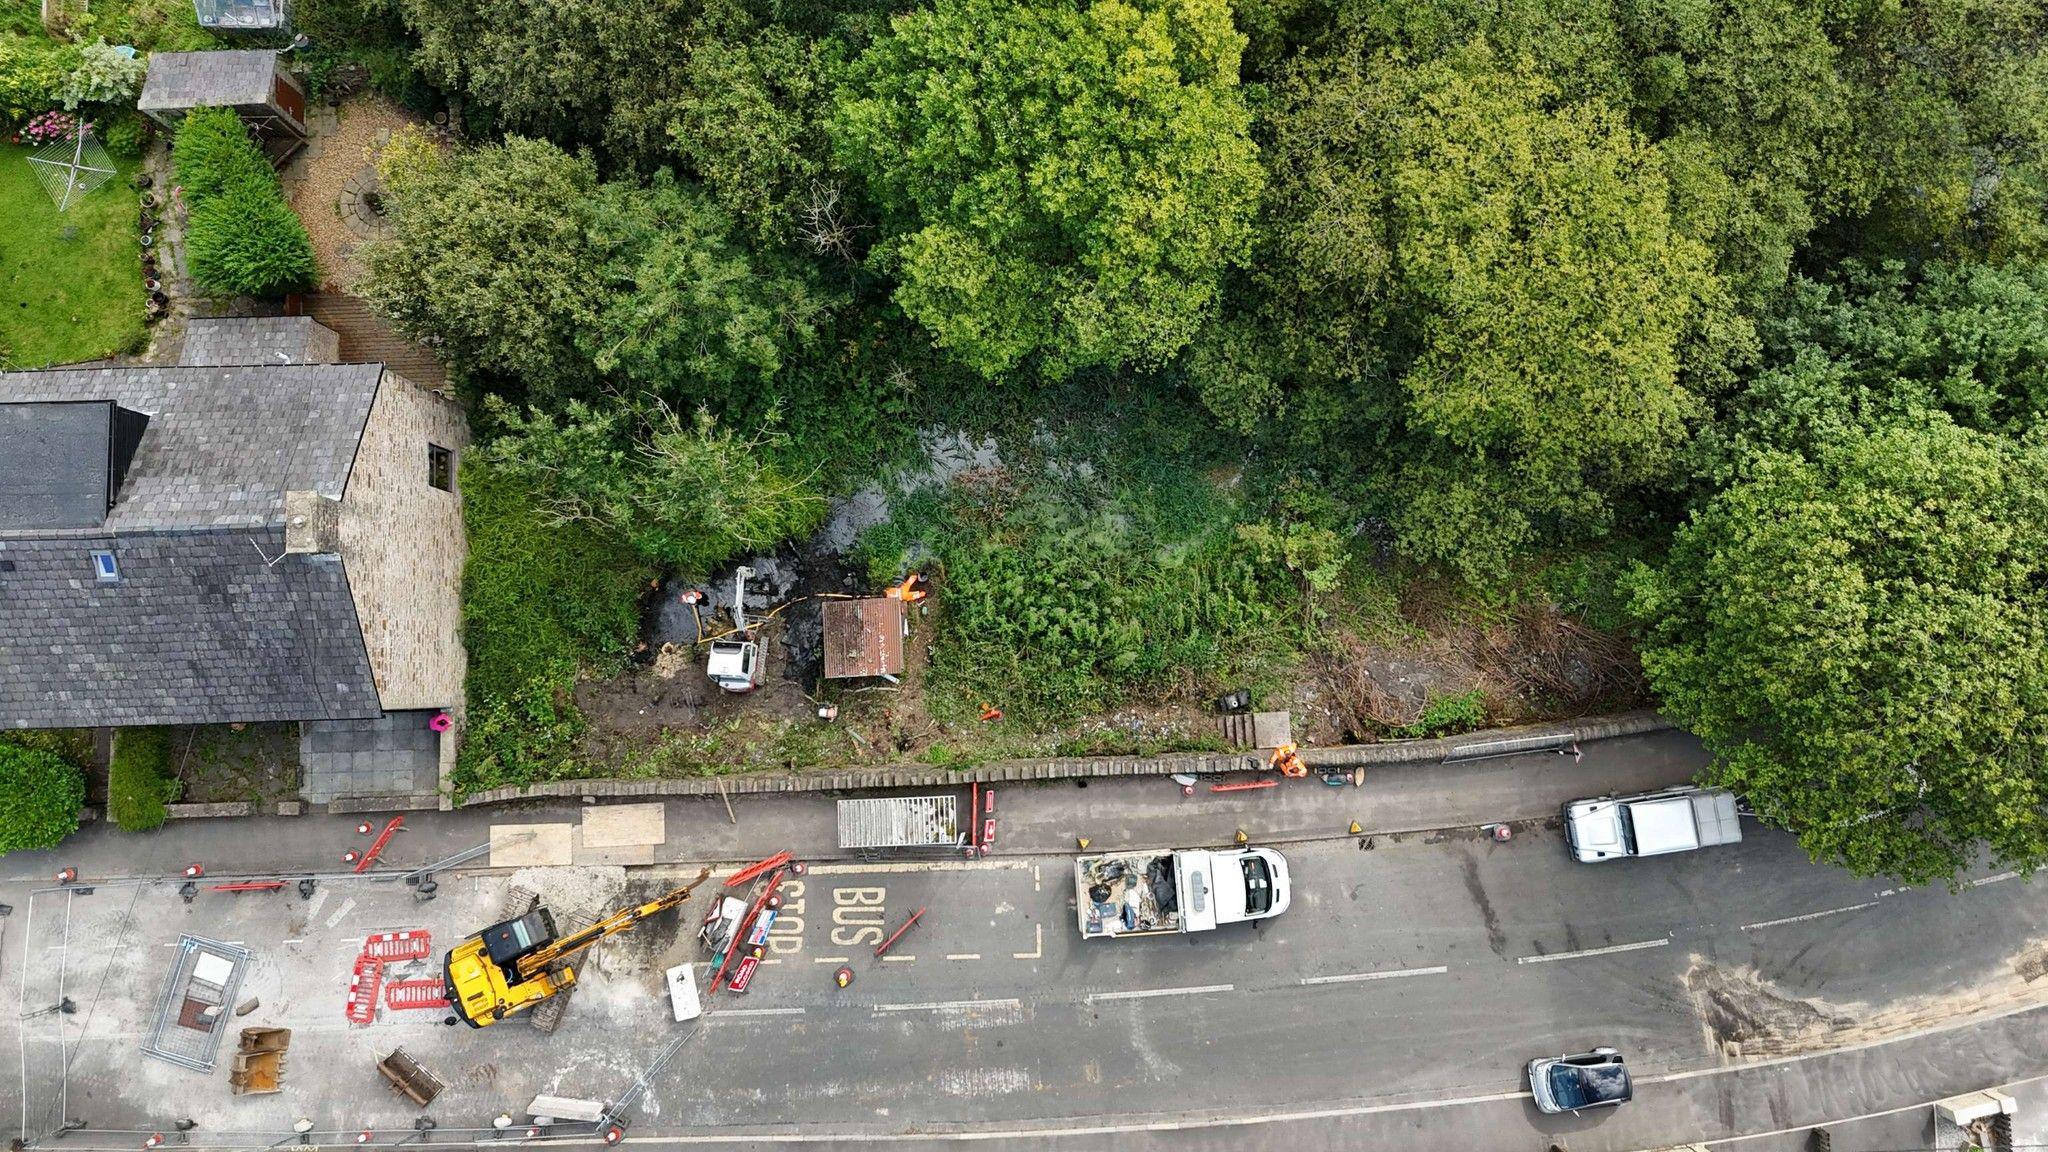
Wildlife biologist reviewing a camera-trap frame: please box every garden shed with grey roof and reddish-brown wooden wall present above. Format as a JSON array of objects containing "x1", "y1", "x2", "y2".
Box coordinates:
[{"x1": 135, "y1": 49, "x2": 305, "y2": 164}]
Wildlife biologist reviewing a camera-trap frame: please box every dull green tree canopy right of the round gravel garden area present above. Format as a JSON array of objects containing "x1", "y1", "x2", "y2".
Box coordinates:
[{"x1": 362, "y1": 137, "x2": 823, "y2": 402}]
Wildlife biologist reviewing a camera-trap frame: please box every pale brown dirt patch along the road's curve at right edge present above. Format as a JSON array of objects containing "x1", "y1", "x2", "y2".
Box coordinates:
[{"x1": 1686, "y1": 941, "x2": 2048, "y2": 1060}]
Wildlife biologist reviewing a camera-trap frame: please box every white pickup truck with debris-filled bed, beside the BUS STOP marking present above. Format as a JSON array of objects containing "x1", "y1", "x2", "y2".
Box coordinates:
[{"x1": 1073, "y1": 849, "x2": 1292, "y2": 941}]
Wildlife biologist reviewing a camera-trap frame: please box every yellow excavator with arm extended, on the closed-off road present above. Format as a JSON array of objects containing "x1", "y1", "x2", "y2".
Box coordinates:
[{"x1": 440, "y1": 869, "x2": 711, "y2": 1031}]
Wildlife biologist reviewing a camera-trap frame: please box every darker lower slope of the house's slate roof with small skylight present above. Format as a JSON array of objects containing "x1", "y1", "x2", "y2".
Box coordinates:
[{"x1": 0, "y1": 527, "x2": 379, "y2": 728}]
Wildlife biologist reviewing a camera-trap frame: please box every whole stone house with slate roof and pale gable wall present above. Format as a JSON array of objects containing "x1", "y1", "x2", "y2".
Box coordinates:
[{"x1": 0, "y1": 318, "x2": 469, "y2": 801}]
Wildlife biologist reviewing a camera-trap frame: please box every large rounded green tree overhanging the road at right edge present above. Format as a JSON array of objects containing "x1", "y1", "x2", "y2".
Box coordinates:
[{"x1": 1630, "y1": 416, "x2": 2048, "y2": 883}]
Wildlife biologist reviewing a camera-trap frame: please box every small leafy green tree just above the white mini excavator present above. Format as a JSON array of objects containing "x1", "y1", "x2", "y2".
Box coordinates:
[{"x1": 489, "y1": 402, "x2": 825, "y2": 578}]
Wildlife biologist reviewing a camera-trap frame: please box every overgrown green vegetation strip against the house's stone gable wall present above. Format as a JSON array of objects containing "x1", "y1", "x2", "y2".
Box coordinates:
[{"x1": 455, "y1": 453, "x2": 653, "y2": 793}]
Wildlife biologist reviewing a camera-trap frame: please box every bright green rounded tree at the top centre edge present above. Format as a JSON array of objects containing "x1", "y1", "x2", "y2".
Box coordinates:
[{"x1": 829, "y1": 0, "x2": 1262, "y2": 377}]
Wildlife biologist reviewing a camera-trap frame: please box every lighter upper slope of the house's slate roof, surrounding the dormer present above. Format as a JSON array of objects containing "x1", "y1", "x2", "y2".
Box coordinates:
[{"x1": 0, "y1": 365, "x2": 383, "y2": 533}]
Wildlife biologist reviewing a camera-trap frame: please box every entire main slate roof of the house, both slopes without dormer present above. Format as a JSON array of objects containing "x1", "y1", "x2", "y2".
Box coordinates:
[{"x1": 0, "y1": 365, "x2": 383, "y2": 728}]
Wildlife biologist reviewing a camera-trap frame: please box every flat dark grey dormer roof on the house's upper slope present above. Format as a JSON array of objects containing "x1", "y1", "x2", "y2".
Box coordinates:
[{"x1": 0, "y1": 400, "x2": 113, "y2": 529}]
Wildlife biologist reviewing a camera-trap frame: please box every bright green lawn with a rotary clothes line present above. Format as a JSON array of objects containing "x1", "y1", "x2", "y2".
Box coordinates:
[{"x1": 0, "y1": 143, "x2": 145, "y2": 369}]
